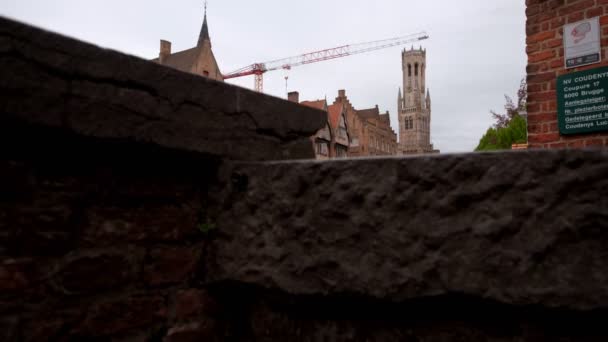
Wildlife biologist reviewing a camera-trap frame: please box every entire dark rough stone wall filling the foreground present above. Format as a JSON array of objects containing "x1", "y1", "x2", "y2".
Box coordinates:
[{"x1": 0, "y1": 15, "x2": 608, "y2": 342}]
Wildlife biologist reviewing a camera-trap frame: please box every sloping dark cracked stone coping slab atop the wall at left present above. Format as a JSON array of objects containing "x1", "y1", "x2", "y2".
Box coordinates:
[{"x1": 0, "y1": 17, "x2": 326, "y2": 160}]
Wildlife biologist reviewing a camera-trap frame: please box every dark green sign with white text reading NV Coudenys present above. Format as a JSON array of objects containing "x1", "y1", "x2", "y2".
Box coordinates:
[{"x1": 557, "y1": 67, "x2": 608, "y2": 135}]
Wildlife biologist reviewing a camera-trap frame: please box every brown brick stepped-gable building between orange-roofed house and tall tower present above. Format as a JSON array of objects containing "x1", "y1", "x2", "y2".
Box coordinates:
[{"x1": 334, "y1": 90, "x2": 398, "y2": 157}]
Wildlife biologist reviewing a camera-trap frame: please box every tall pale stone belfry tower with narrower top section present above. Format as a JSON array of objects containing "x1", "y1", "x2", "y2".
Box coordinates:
[{"x1": 397, "y1": 47, "x2": 439, "y2": 154}]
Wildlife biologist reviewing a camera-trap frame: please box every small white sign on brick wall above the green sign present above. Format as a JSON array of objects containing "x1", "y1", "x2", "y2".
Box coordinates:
[{"x1": 564, "y1": 17, "x2": 602, "y2": 68}]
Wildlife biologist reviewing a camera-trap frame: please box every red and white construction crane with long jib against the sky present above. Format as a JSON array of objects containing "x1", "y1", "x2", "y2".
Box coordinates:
[{"x1": 223, "y1": 32, "x2": 429, "y2": 93}]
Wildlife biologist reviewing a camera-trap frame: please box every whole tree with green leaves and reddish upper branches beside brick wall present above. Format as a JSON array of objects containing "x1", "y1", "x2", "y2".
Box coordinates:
[{"x1": 475, "y1": 79, "x2": 528, "y2": 151}]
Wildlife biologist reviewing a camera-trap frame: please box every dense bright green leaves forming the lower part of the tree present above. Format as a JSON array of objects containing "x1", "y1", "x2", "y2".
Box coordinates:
[{"x1": 475, "y1": 115, "x2": 527, "y2": 151}]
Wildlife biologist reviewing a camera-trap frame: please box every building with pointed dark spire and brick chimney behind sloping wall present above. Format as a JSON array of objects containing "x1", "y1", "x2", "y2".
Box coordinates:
[{"x1": 153, "y1": 8, "x2": 224, "y2": 81}]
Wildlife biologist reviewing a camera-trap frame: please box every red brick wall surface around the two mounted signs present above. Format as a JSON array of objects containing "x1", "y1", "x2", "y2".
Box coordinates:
[{"x1": 526, "y1": 0, "x2": 608, "y2": 148}]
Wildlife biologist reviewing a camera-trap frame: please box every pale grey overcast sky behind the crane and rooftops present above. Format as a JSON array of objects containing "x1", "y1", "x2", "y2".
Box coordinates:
[{"x1": 0, "y1": 0, "x2": 526, "y2": 152}]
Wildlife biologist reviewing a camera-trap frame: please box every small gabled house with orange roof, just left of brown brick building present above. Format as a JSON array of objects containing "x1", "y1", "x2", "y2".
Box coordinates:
[{"x1": 288, "y1": 92, "x2": 350, "y2": 160}]
